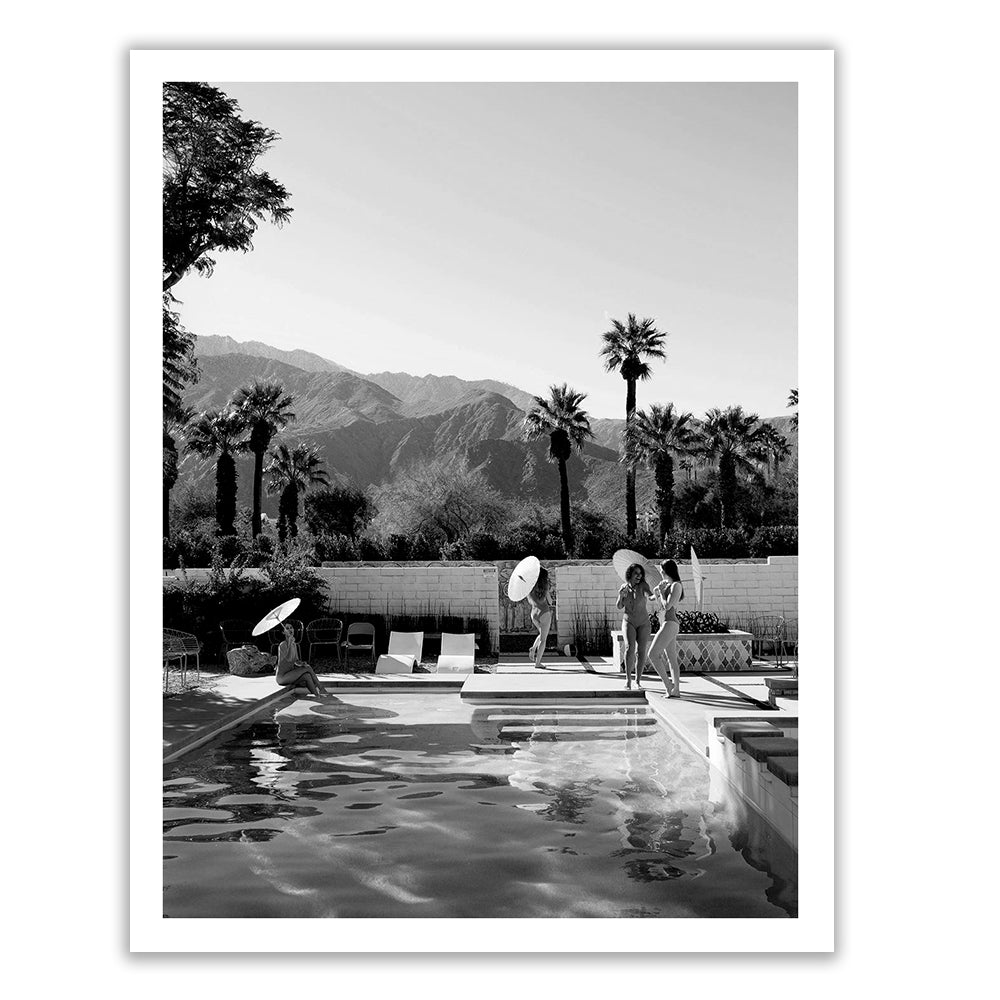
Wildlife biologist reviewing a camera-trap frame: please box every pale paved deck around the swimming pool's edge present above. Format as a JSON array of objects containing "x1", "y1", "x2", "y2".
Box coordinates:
[{"x1": 163, "y1": 654, "x2": 788, "y2": 760}]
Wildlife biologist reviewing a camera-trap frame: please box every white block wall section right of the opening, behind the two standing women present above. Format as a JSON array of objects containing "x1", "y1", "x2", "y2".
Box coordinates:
[{"x1": 546, "y1": 556, "x2": 798, "y2": 645}]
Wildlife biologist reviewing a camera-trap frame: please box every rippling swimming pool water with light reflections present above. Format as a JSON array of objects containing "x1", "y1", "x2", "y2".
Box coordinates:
[{"x1": 163, "y1": 693, "x2": 797, "y2": 917}]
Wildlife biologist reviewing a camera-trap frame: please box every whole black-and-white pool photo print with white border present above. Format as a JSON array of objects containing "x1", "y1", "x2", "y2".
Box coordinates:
[{"x1": 130, "y1": 50, "x2": 835, "y2": 952}]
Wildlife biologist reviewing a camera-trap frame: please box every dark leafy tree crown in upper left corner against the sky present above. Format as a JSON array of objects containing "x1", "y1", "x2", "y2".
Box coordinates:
[{"x1": 163, "y1": 83, "x2": 292, "y2": 291}]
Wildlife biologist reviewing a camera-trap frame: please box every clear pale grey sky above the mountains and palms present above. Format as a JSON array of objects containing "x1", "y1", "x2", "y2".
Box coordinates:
[{"x1": 173, "y1": 83, "x2": 797, "y2": 417}]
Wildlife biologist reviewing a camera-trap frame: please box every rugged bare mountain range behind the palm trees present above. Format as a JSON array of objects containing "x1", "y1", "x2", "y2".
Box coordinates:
[{"x1": 179, "y1": 336, "x2": 797, "y2": 519}]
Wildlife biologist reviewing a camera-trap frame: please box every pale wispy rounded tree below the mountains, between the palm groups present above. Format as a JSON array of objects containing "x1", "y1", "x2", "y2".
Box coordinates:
[{"x1": 374, "y1": 455, "x2": 510, "y2": 546}]
